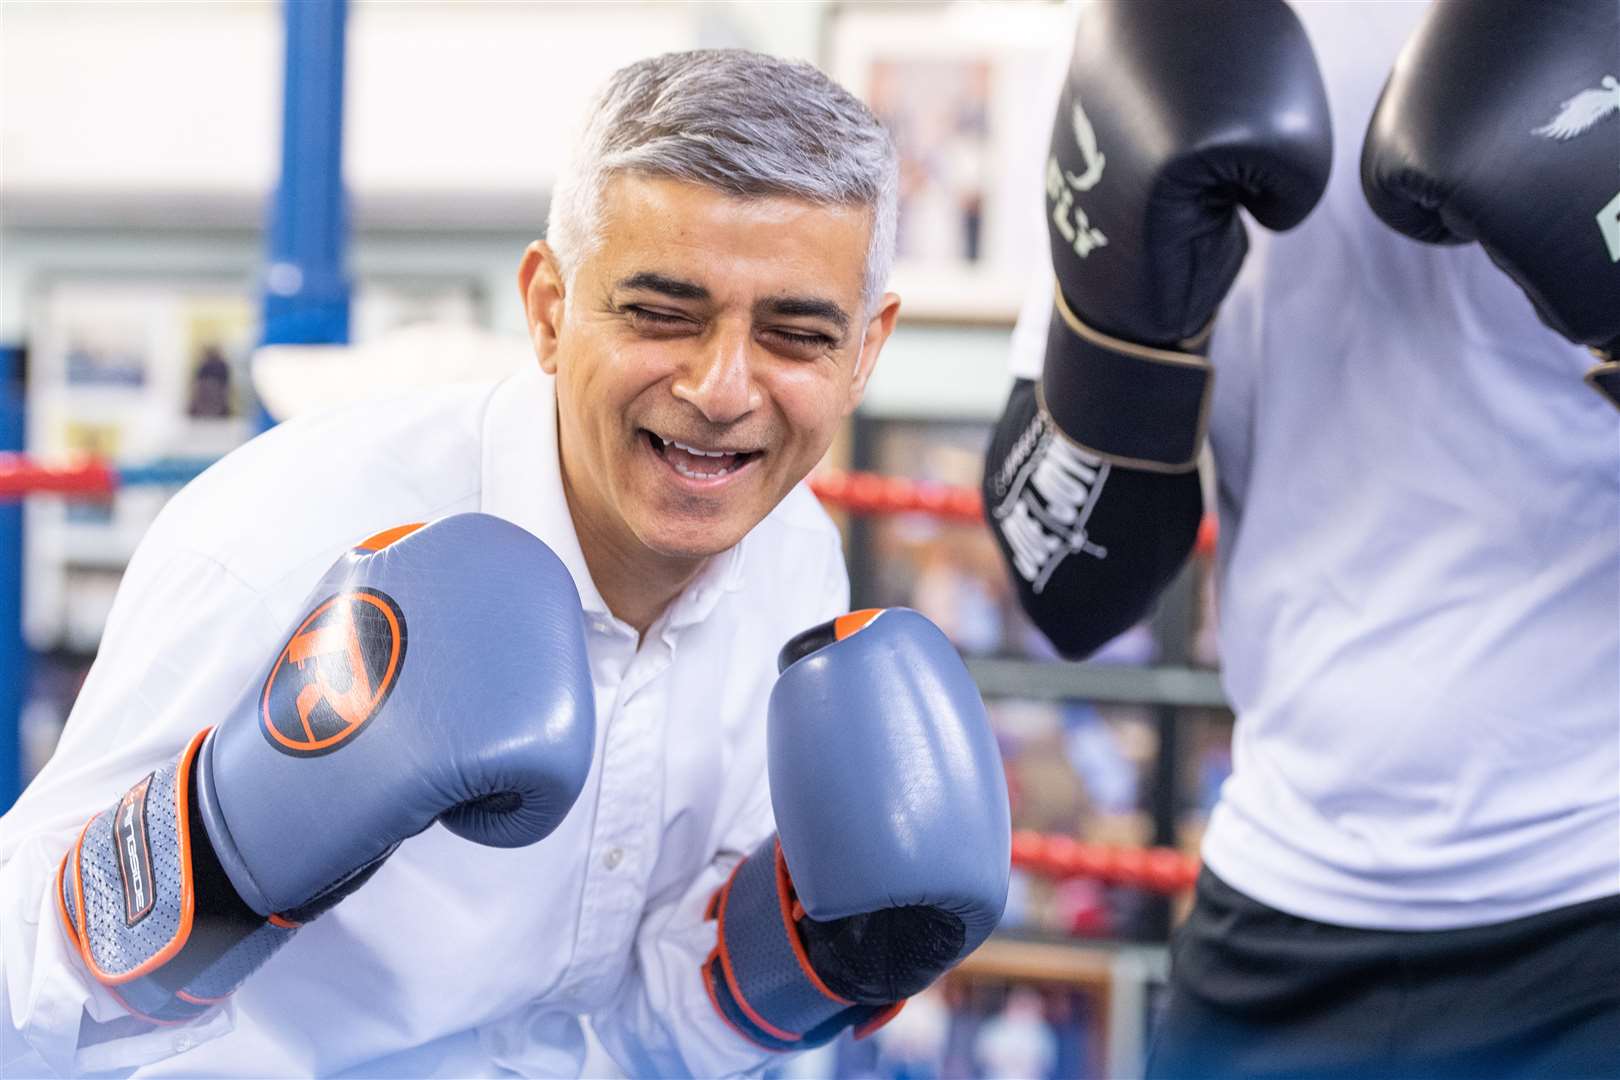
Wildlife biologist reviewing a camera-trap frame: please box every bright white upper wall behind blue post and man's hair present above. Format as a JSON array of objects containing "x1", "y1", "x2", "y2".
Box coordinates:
[{"x1": 0, "y1": 0, "x2": 806, "y2": 201}]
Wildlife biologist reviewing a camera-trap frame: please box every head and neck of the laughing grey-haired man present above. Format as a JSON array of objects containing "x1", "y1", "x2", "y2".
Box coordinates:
[{"x1": 518, "y1": 50, "x2": 899, "y2": 630}]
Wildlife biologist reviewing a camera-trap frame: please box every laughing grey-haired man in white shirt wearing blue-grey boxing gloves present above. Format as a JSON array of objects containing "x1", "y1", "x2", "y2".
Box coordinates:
[{"x1": 0, "y1": 50, "x2": 1008, "y2": 1077}]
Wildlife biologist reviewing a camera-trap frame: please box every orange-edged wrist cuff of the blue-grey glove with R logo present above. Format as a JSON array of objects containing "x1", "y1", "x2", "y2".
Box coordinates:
[{"x1": 57, "y1": 729, "x2": 298, "y2": 1023}]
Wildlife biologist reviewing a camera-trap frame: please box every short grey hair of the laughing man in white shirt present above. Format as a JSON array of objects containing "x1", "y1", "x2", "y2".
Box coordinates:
[{"x1": 546, "y1": 49, "x2": 899, "y2": 309}]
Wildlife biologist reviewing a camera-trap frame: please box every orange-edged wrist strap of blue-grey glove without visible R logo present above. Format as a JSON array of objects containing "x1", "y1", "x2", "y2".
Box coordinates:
[{"x1": 716, "y1": 836, "x2": 854, "y2": 1049}]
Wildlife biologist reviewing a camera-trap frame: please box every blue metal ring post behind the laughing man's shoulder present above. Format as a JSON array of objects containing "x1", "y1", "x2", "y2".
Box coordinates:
[{"x1": 259, "y1": 0, "x2": 350, "y2": 427}]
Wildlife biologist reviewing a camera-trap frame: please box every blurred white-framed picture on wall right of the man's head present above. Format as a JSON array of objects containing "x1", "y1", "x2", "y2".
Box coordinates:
[{"x1": 826, "y1": 0, "x2": 1068, "y2": 324}]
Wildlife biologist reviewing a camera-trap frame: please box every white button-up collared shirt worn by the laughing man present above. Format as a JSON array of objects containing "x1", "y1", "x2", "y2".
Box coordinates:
[{"x1": 0, "y1": 371, "x2": 849, "y2": 1080}]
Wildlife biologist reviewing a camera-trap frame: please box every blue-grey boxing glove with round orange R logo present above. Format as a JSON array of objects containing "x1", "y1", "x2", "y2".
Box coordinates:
[{"x1": 57, "y1": 513, "x2": 596, "y2": 1022}]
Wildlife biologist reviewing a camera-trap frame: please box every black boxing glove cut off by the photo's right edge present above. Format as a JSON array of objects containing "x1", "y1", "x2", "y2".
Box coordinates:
[{"x1": 1361, "y1": 0, "x2": 1620, "y2": 406}]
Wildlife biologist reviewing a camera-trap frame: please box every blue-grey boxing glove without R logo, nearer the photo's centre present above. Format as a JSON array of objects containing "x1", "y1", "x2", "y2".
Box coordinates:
[{"x1": 703, "y1": 609, "x2": 1011, "y2": 1049}]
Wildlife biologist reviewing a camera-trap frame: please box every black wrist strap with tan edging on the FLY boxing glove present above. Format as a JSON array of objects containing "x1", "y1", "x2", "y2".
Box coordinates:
[{"x1": 1035, "y1": 290, "x2": 1215, "y2": 473}]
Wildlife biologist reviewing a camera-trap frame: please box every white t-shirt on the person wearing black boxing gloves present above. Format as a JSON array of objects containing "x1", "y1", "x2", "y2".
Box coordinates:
[{"x1": 1013, "y1": 3, "x2": 1620, "y2": 929}]
